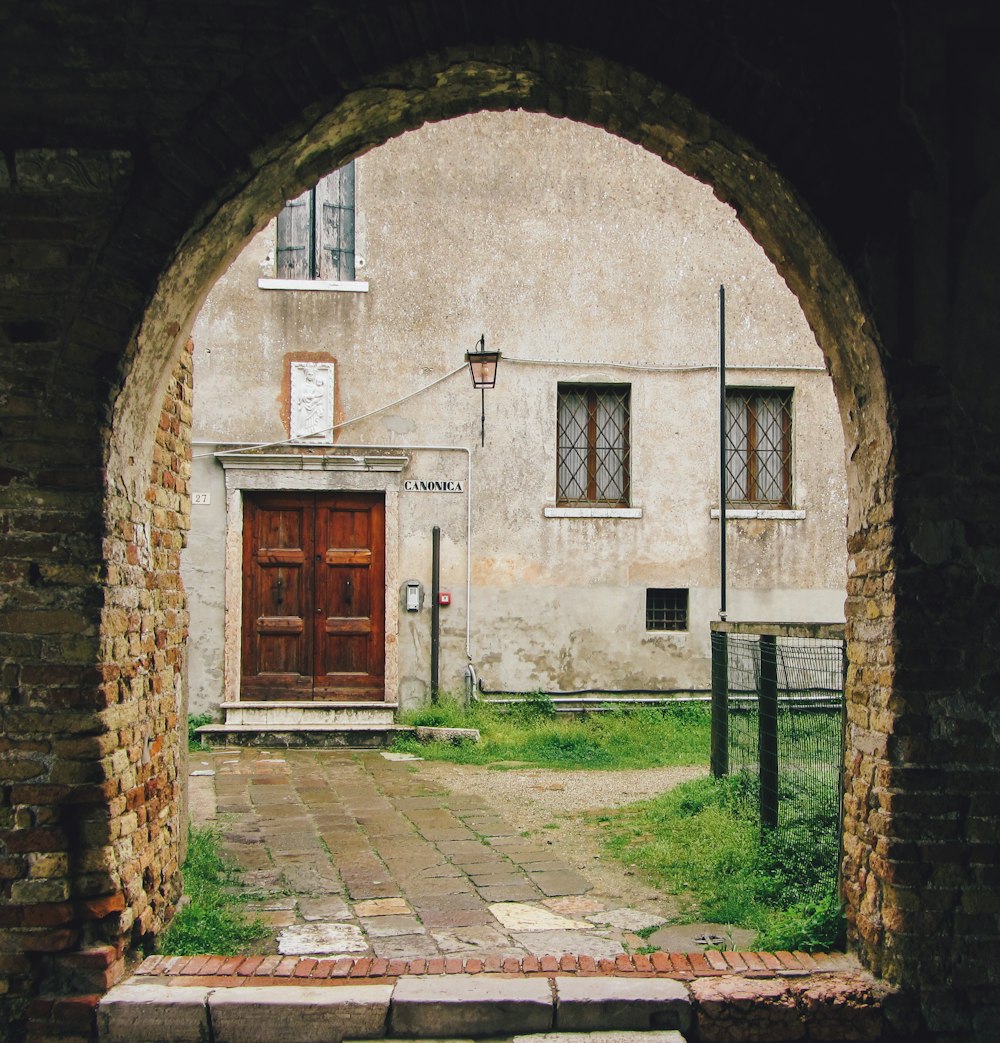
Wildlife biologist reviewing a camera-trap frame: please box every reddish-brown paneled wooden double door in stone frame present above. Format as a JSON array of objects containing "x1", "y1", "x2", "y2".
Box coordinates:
[{"x1": 240, "y1": 492, "x2": 386, "y2": 701}]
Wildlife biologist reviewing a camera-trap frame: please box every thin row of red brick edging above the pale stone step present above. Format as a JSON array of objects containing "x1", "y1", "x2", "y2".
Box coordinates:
[{"x1": 135, "y1": 950, "x2": 859, "y2": 986}]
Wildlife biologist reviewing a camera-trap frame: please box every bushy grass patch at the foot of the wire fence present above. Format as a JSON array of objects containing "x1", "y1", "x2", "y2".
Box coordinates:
[{"x1": 597, "y1": 773, "x2": 844, "y2": 951}]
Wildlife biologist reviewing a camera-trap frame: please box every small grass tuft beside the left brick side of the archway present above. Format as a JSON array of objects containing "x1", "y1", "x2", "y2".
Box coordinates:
[{"x1": 158, "y1": 826, "x2": 270, "y2": 956}]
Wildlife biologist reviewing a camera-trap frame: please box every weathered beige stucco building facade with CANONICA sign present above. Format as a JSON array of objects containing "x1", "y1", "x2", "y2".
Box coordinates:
[{"x1": 181, "y1": 113, "x2": 847, "y2": 714}]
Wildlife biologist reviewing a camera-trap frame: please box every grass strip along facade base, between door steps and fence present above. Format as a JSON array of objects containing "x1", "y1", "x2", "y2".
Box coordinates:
[{"x1": 395, "y1": 695, "x2": 711, "y2": 770}]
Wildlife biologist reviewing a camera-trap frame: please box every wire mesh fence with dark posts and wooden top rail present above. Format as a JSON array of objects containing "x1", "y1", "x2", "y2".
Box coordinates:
[{"x1": 712, "y1": 624, "x2": 845, "y2": 830}]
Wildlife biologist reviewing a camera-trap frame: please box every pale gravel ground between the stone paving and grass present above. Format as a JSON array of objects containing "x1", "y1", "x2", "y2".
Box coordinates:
[{"x1": 414, "y1": 760, "x2": 707, "y2": 916}]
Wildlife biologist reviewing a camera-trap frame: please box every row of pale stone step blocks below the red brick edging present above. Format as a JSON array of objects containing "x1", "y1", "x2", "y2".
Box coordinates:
[{"x1": 98, "y1": 975, "x2": 692, "y2": 1043}]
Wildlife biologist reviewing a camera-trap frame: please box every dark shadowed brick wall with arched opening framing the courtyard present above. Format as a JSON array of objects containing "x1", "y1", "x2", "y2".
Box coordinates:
[{"x1": 0, "y1": 0, "x2": 1000, "y2": 1040}]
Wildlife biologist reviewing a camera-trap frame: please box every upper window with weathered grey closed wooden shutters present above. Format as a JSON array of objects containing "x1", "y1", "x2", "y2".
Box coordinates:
[{"x1": 275, "y1": 161, "x2": 355, "y2": 282}]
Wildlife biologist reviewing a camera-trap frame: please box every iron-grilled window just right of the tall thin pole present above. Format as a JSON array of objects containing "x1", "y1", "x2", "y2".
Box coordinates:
[{"x1": 726, "y1": 388, "x2": 791, "y2": 507}]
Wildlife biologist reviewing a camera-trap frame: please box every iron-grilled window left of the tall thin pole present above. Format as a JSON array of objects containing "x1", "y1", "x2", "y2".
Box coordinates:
[{"x1": 556, "y1": 384, "x2": 631, "y2": 507}]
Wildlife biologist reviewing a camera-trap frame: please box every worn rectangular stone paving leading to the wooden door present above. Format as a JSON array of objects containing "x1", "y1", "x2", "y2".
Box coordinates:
[{"x1": 190, "y1": 749, "x2": 696, "y2": 960}]
